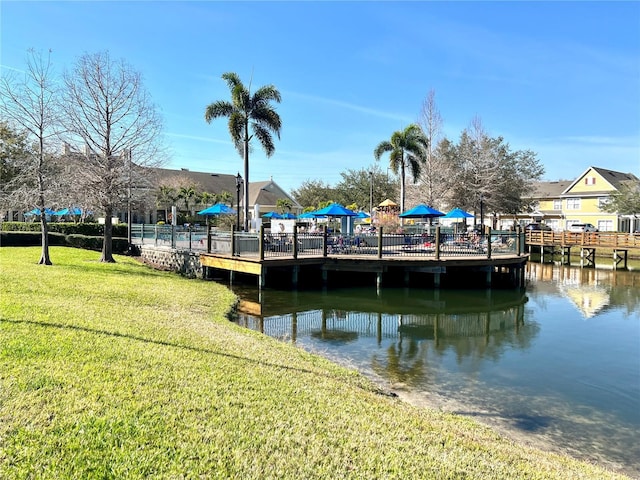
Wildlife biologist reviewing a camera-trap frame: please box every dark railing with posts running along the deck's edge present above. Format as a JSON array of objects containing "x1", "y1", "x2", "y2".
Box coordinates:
[{"x1": 131, "y1": 224, "x2": 524, "y2": 259}]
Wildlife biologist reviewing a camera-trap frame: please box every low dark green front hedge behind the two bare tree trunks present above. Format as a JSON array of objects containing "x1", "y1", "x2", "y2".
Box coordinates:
[{"x1": 0, "y1": 231, "x2": 128, "y2": 254}]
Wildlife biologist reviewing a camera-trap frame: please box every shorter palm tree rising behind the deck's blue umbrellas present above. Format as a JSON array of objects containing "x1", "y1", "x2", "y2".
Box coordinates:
[{"x1": 373, "y1": 123, "x2": 429, "y2": 212}]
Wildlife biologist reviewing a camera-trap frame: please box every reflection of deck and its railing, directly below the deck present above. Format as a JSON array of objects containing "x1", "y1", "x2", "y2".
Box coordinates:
[{"x1": 238, "y1": 291, "x2": 527, "y2": 343}]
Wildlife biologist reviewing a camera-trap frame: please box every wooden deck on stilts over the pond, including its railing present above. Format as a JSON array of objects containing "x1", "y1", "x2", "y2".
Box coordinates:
[{"x1": 200, "y1": 228, "x2": 528, "y2": 291}]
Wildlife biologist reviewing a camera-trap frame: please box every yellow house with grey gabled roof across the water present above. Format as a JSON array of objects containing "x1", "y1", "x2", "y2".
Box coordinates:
[{"x1": 559, "y1": 167, "x2": 640, "y2": 232}]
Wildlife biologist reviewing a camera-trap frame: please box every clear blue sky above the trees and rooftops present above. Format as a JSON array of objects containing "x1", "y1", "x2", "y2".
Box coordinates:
[{"x1": 0, "y1": 0, "x2": 640, "y2": 190}]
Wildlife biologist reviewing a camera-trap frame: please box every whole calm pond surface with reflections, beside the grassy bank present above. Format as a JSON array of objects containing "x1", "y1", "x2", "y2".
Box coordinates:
[{"x1": 233, "y1": 262, "x2": 640, "y2": 478}]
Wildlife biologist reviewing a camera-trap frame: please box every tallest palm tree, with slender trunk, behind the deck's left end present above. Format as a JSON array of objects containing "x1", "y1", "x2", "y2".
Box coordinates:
[{"x1": 204, "y1": 72, "x2": 282, "y2": 231}]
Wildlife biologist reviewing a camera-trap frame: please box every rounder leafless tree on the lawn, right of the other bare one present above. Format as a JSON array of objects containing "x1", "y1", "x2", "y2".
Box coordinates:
[{"x1": 63, "y1": 52, "x2": 164, "y2": 262}]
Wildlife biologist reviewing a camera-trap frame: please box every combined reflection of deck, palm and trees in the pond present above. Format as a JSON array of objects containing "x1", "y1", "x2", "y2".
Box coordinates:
[{"x1": 238, "y1": 289, "x2": 539, "y2": 386}]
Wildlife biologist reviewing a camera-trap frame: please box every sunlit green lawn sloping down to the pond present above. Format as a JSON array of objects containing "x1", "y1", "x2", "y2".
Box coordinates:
[{"x1": 0, "y1": 247, "x2": 624, "y2": 480}]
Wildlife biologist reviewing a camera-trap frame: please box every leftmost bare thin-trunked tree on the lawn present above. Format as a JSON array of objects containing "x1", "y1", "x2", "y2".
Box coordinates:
[{"x1": 0, "y1": 50, "x2": 60, "y2": 265}]
